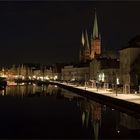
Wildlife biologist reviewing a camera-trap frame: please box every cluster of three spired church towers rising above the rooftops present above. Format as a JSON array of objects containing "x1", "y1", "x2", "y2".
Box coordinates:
[{"x1": 80, "y1": 10, "x2": 101, "y2": 62}]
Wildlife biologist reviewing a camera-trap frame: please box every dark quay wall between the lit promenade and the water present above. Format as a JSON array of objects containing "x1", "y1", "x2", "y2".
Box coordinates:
[{"x1": 50, "y1": 82, "x2": 140, "y2": 118}]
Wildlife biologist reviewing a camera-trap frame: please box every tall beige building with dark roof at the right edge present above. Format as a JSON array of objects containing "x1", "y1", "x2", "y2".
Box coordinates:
[{"x1": 120, "y1": 35, "x2": 140, "y2": 93}]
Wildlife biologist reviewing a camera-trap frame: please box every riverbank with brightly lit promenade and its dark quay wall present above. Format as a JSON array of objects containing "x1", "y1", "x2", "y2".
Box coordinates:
[{"x1": 50, "y1": 82, "x2": 140, "y2": 118}]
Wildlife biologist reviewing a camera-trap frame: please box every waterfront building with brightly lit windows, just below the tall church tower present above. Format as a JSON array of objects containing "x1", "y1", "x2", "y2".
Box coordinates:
[{"x1": 90, "y1": 58, "x2": 120, "y2": 86}]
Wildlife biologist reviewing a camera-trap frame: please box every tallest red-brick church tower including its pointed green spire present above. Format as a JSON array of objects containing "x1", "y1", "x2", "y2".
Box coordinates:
[{"x1": 90, "y1": 9, "x2": 101, "y2": 60}]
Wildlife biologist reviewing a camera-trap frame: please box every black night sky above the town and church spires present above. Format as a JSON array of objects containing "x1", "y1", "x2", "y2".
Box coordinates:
[{"x1": 0, "y1": 1, "x2": 140, "y2": 65}]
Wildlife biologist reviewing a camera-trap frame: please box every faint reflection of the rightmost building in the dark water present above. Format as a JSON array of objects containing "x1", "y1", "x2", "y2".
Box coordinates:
[{"x1": 120, "y1": 112, "x2": 140, "y2": 130}]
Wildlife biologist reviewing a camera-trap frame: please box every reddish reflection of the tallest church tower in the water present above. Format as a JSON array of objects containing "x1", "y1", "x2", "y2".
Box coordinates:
[{"x1": 90, "y1": 101, "x2": 101, "y2": 139}]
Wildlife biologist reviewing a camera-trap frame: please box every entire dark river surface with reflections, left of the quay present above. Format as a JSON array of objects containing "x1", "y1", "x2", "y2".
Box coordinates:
[{"x1": 0, "y1": 85, "x2": 140, "y2": 139}]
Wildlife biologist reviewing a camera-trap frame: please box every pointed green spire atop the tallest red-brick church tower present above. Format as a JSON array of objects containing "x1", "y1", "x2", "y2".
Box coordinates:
[{"x1": 93, "y1": 9, "x2": 99, "y2": 39}]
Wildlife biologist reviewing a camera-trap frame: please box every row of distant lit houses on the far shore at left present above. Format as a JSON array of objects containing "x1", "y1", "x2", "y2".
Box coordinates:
[{"x1": 3, "y1": 64, "x2": 61, "y2": 81}]
